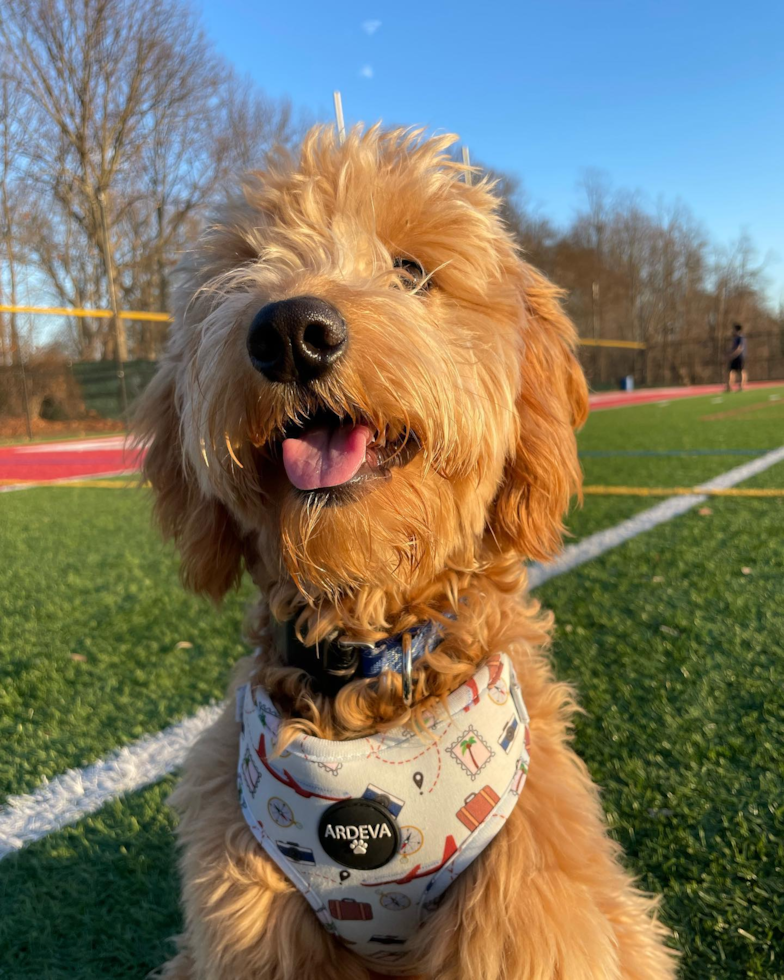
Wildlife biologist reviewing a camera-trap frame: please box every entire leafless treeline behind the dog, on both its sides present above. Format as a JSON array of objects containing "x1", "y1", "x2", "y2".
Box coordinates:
[{"x1": 0, "y1": 0, "x2": 784, "y2": 375}]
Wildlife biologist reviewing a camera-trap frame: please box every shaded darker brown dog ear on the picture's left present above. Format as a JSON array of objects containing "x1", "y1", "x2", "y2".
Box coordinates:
[{"x1": 133, "y1": 363, "x2": 245, "y2": 602}]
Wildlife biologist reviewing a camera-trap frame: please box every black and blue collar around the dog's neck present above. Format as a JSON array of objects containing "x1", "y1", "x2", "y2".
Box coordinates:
[{"x1": 271, "y1": 619, "x2": 443, "y2": 704}]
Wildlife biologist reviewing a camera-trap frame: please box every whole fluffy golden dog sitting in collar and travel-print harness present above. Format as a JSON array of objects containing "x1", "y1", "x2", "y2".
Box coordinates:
[{"x1": 136, "y1": 126, "x2": 675, "y2": 980}]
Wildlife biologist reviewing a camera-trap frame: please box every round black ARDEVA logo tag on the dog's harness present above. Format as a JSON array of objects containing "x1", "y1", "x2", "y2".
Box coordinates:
[{"x1": 319, "y1": 799, "x2": 400, "y2": 871}]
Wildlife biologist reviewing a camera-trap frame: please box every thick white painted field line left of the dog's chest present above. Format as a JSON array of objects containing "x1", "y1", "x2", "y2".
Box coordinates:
[{"x1": 0, "y1": 704, "x2": 223, "y2": 861}]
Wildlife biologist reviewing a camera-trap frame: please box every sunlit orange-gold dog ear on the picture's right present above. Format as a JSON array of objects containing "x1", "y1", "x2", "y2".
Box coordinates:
[{"x1": 489, "y1": 262, "x2": 588, "y2": 560}]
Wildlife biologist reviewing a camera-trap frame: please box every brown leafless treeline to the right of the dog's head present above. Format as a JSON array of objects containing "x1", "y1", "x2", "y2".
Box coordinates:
[{"x1": 500, "y1": 171, "x2": 784, "y2": 381}]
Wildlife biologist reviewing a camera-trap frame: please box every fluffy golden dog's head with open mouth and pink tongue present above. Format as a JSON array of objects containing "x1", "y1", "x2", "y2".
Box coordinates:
[{"x1": 138, "y1": 128, "x2": 586, "y2": 618}]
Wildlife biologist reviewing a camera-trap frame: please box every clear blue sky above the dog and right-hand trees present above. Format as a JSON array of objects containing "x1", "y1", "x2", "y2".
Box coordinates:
[{"x1": 200, "y1": 0, "x2": 784, "y2": 304}]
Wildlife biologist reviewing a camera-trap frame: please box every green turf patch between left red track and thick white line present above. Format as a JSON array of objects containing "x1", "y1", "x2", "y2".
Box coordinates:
[{"x1": 0, "y1": 487, "x2": 250, "y2": 800}]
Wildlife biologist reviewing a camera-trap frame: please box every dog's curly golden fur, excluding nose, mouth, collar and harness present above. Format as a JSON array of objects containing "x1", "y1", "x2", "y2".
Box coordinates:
[{"x1": 137, "y1": 127, "x2": 675, "y2": 980}]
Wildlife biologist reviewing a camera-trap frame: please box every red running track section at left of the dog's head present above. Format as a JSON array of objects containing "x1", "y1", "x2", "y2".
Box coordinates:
[{"x1": 0, "y1": 436, "x2": 141, "y2": 485}]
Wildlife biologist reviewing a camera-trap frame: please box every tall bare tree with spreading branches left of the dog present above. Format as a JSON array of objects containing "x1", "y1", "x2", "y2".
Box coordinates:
[{"x1": 0, "y1": 0, "x2": 293, "y2": 358}]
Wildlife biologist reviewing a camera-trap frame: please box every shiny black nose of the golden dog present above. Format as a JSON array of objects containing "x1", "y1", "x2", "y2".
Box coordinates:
[{"x1": 248, "y1": 296, "x2": 348, "y2": 382}]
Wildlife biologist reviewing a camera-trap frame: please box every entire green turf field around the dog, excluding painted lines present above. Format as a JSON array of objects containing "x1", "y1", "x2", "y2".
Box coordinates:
[{"x1": 0, "y1": 389, "x2": 784, "y2": 980}]
